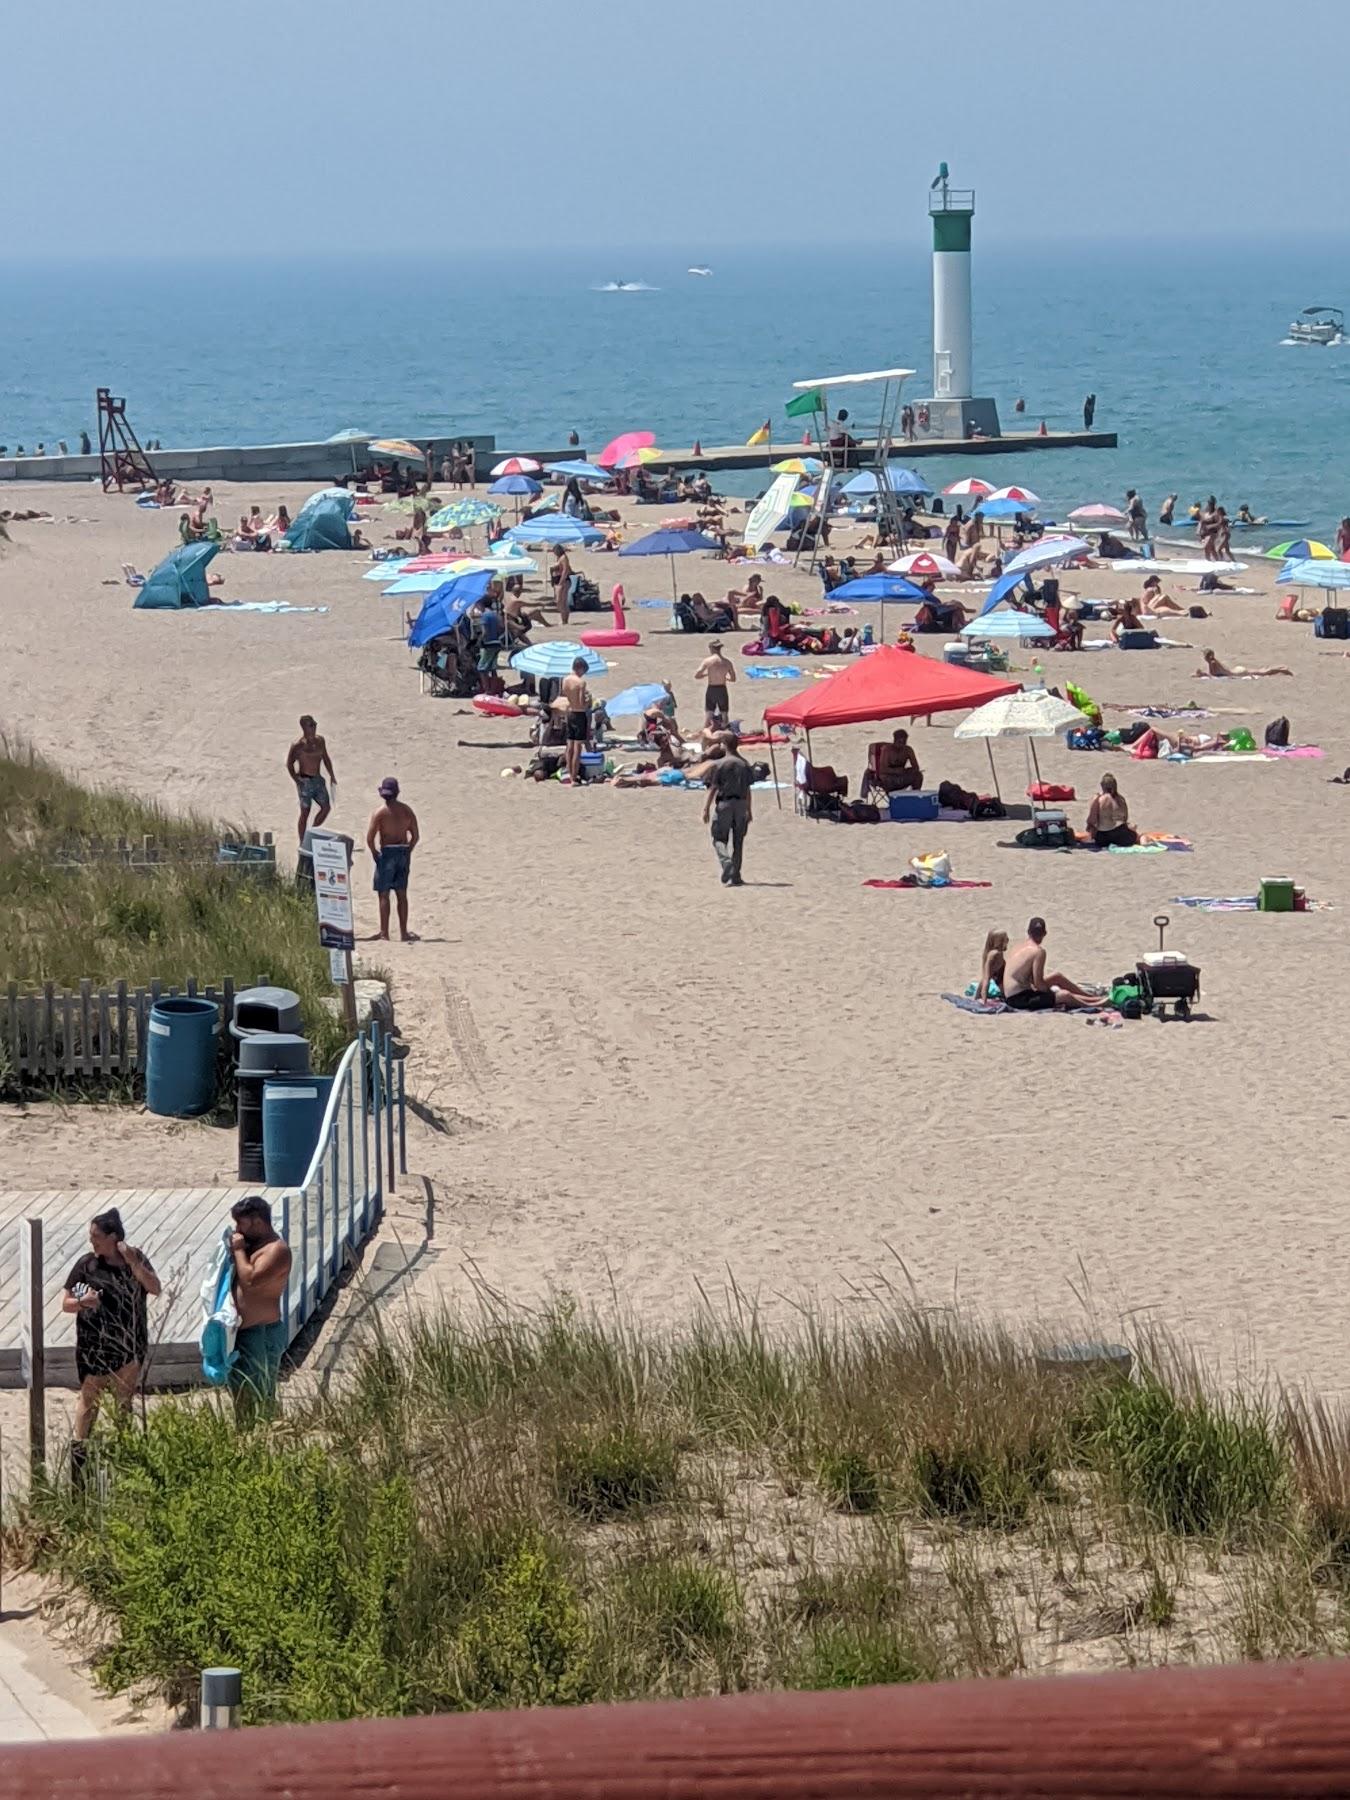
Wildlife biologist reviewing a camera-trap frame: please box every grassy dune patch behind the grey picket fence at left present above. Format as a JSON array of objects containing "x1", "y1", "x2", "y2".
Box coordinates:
[{"x1": 0, "y1": 738, "x2": 346, "y2": 1091}]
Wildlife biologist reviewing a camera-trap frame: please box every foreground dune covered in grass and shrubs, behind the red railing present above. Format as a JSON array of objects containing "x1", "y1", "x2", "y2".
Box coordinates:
[{"x1": 11, "y1": 1303, "x2": 1350, "y2": 1721}]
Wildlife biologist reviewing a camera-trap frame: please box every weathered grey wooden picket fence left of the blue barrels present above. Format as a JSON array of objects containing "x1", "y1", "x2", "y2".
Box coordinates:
[{"x1": 0, "y1": 976, "x2": 261, "y2": 1085}]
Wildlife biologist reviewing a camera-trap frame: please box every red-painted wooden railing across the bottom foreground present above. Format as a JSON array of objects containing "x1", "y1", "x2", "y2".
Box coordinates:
[{"x1": 0, "y1": 1661, "x2": 1350, "y2": 1800}]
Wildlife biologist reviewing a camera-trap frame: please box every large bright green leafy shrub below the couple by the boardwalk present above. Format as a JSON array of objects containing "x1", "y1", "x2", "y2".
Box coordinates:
[{"x1": 40, "y1": 1406, "x2": 418, "y2": 1723}]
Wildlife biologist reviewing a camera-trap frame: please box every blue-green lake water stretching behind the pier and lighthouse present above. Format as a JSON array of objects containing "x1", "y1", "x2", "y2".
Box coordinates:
[{"x1": 0, "y1": 243, "x2": 1350, "y2": 535}]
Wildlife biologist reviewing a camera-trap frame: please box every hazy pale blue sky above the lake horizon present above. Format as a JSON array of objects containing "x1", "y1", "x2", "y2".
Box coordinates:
[{"x1": 0, "y1": 0, "x2": 1350, "y2": 261}]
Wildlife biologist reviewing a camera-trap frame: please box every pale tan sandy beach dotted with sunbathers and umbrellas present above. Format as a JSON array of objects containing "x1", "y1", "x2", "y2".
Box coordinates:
[{"x1": 0, "y1": 482, "x2": 1350, "y2": 1395}]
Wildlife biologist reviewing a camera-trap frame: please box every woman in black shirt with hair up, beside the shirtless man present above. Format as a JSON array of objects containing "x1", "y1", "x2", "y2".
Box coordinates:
[{"x1": 61, "y1": 1208, "x2": 160, "y2": 1445}]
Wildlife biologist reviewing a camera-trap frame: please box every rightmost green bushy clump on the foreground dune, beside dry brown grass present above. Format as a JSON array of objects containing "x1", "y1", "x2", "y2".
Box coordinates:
[{"x1": 1085, "y1": 1375, "x2": 1289, "y2": 1537}]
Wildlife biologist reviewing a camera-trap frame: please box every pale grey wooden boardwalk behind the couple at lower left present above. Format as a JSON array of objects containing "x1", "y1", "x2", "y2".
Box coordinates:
[{"x1": 0, "y1": 1186, "x2": 286, "y2": 1388}]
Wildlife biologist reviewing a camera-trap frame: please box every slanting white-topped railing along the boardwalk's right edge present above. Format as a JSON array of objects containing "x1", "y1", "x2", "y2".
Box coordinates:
[{"x1": 281, "y1": 1019, "x2": 407, "y2": 1343}]
